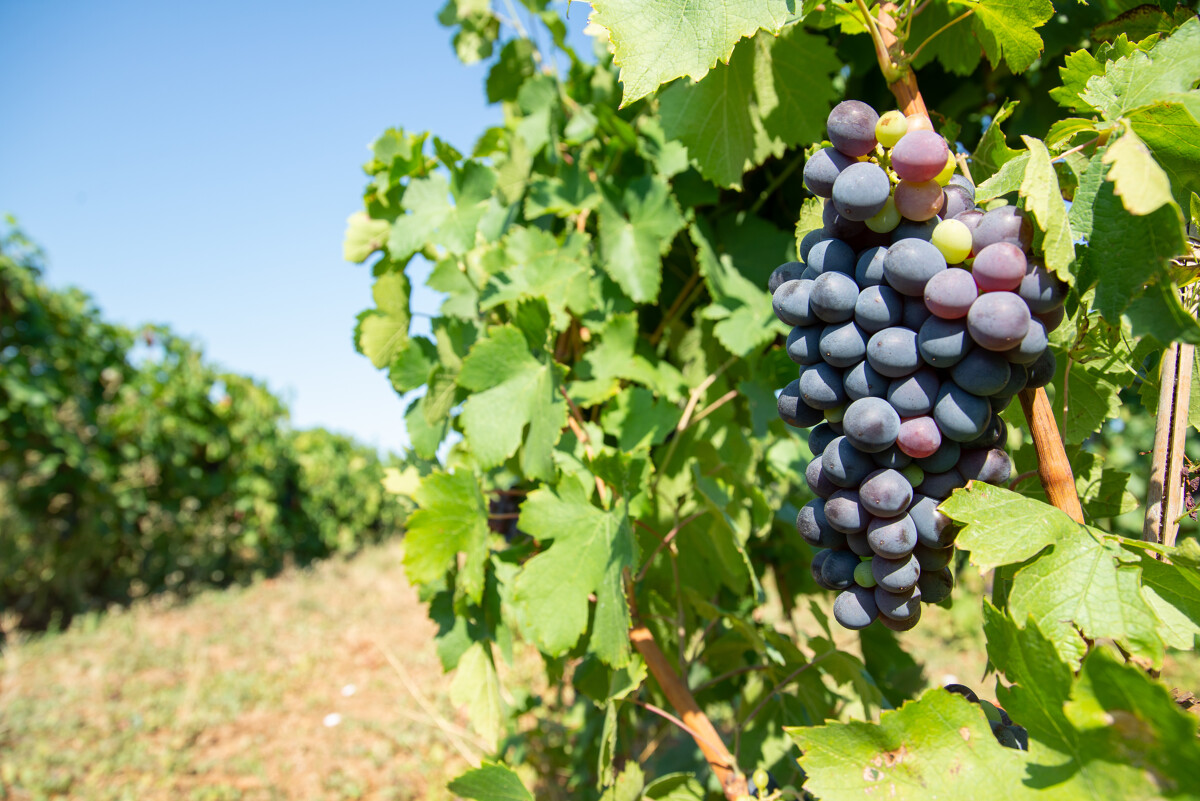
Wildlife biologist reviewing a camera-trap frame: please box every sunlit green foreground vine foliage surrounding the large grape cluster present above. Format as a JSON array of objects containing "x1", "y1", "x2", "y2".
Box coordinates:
[{"x1": 344, "y1": 0, "x2": 1200, "y2": 800}]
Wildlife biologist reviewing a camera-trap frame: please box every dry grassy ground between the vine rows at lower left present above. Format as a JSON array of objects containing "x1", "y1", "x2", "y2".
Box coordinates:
[{"x1": 0, "y1": 543, "x2": 469, "y2": 801}]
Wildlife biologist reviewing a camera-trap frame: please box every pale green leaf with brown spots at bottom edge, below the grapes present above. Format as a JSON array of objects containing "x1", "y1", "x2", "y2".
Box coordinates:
[{"x1": 785, "y1": 687, "x2": 1025, "y2": 801}]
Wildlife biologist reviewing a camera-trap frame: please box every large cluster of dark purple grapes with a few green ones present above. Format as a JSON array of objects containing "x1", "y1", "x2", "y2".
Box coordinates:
[{"x1": 769, "y1": 101, "x2": 1066, "y2": 631}]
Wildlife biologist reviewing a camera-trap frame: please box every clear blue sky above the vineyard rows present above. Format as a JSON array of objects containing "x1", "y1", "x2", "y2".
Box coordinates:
[{"x1": 0, "y1": 0, "x2": 589, "y2": 450}]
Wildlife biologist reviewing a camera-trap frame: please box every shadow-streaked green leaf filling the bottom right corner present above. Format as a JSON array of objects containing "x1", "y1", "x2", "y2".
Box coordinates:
[{"x1": 984, "y1": 602, "x2": 1200, "y2": 800}]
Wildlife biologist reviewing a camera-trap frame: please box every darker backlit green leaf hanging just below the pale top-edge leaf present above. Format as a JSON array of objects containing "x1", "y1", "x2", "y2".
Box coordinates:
[{"x1": 659, "y1": 40, "x2": 779, "y2": 188}]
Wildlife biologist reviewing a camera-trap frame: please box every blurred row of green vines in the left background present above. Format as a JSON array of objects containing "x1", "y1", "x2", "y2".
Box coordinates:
[{"x1": 0, "y1": 226, "x2": 404, "y2": 627}]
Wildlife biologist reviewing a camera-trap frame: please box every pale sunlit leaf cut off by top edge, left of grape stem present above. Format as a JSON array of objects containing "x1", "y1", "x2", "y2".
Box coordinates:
[{"x1": 592, "y1": 0, "x2": 793, "y2": 106}]
